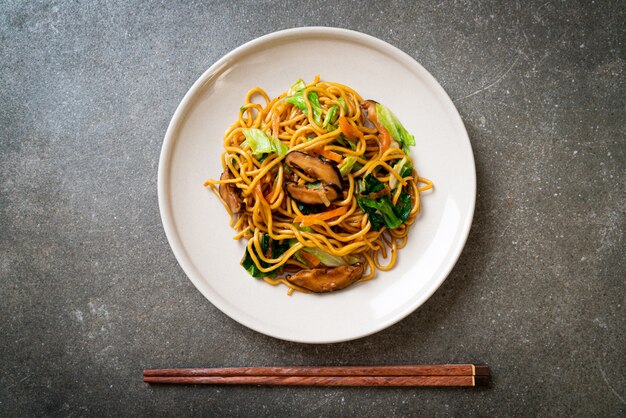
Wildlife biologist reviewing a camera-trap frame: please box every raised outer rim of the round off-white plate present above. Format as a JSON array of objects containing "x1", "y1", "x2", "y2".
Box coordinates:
[{"x1": 157, "y1": 26, "x2": 477, "y2": 344}]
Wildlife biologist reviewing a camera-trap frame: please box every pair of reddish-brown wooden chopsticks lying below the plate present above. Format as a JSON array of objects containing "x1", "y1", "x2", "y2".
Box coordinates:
[{"x1": 143, "y1": 364, "x2": 489, "y2": 387}]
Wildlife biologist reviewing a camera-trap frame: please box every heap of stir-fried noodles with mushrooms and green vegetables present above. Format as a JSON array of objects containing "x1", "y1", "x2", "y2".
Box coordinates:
[{"x1": 205, "y1": 77, "x2": 432, "y2": 294}]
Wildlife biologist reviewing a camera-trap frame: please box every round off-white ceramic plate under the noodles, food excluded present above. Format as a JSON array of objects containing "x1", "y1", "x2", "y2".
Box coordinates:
[{"x1": 158, "y1": 27, "x2": 476, "y2": 343}]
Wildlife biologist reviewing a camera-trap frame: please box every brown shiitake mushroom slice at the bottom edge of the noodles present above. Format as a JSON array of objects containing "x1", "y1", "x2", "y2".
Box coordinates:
[{"x1": 287, "y1": 263, "x2": 365, "y2": 293}]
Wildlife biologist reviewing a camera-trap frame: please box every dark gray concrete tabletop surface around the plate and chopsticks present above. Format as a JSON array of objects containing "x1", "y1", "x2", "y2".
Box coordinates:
[{"x1": 0, "y1": 0, "x2": 626, "y2": 417}]
